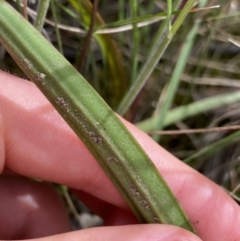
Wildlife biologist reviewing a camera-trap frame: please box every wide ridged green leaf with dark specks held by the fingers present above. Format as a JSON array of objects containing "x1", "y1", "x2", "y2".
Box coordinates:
[{"x1": 0, "y1": 0, "x2": 194, "y2": 232}]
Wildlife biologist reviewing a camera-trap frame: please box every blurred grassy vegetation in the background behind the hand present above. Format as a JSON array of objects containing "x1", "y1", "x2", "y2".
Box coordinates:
[{"x1": 0, "y1": 0, "x2": 240, "y2": 227}]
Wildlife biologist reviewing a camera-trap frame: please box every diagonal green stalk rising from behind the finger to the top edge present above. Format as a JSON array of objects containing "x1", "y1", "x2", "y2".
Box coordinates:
[{"x1": 117, "y1": 0, "x2": 195, "y2": 115}]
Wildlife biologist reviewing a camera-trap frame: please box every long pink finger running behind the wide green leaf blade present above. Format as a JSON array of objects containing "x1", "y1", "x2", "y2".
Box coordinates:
[{"x1": 0, "y1": 73, "x2": 240, "y2": 240}]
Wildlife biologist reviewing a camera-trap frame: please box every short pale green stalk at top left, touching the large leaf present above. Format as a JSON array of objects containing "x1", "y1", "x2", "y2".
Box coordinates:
[{"x1": 34, "y1": 0, "x2": 50, "y2": 32}]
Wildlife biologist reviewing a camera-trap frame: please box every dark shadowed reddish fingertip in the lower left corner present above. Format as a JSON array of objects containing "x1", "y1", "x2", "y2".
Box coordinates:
[{"x1": 0, "y1": 176, "x2": 71, "y2": 240}]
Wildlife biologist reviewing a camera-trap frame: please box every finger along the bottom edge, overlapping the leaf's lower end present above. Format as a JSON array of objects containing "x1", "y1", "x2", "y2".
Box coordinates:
[{"x1": 26, "y1": 224, "x2": 201, "y2": 241}]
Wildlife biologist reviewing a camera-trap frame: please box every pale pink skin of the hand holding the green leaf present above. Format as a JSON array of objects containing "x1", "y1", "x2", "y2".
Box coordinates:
[{"x1": 0, "y1": 72, "x2": 240, "y2": 241}]
